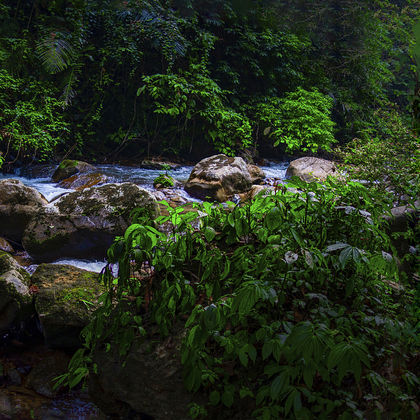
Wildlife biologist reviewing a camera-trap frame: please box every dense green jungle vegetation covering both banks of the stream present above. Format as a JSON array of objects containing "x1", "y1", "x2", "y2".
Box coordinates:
[{"x1": 0, "y1": 0, "x2": 420, "y2": 420}]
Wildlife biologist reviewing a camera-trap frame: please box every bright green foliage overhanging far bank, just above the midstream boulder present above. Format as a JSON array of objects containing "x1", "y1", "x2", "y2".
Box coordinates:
[{"x1": 138, "y1": 65, "x2": 251, "y2": 155}]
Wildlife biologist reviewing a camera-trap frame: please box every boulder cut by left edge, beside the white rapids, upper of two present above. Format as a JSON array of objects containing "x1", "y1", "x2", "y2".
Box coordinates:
[{"x1": 0, "y1": 179, "x2": 48, "y2": 242}]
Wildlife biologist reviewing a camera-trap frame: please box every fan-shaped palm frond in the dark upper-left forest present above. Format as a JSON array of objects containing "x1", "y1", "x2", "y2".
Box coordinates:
[{"x1": 36, "y1": 33, "x2": 75, "y2": 74}]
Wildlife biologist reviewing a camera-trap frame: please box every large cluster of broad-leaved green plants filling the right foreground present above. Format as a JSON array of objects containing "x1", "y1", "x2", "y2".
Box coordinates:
[{"x1": 61, "y1": 179, "x2": 420, "y2": 419}]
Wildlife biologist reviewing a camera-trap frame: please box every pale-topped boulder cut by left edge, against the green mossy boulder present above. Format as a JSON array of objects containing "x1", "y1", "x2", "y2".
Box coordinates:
[{"x1": 0, "y1": 252, "x2": 33, "y2": 332}]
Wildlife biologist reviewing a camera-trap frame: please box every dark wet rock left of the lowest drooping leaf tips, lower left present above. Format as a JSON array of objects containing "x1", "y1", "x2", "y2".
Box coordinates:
[{"x1": 26, "y1": 353, "x2": 70, "y2": 398}]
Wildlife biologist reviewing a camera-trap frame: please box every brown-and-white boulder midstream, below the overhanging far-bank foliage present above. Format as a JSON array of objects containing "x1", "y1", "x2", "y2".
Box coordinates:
[{"x1": 185, "y1": 154, "x2": 252, "y2": 201}]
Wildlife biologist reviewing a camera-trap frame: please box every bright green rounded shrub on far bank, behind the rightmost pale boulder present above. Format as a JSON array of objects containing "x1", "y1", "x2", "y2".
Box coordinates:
[{"x1": 255, "y1": 88, "x2": 335, "y2": 152}]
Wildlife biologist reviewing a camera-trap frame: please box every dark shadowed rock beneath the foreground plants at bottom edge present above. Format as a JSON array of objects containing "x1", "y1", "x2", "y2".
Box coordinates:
[{"x1": 88, "y1": 327, "x2": 204, "y2": 420}]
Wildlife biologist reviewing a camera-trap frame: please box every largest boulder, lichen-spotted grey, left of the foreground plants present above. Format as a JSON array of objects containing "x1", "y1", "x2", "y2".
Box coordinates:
[{"x1": 22, "y1": 183, "x2": 159, "y2": 262}]
